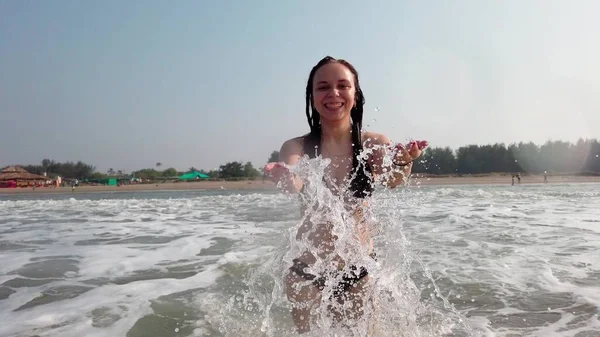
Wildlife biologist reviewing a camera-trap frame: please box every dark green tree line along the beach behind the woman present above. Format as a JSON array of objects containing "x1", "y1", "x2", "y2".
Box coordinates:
[{"x1": 7, "y1": 139, "x2": 600, "y2": 180}]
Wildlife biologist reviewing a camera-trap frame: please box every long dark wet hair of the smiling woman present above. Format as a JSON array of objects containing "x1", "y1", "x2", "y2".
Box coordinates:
[{"x1": 304, "y1": 56, "x2": 373, "y2": 198}]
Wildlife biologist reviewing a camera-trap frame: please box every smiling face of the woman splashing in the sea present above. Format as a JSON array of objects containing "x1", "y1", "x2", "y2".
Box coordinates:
[{"x1": 312, "y1": 63, "x2": 356, "y2": 122}]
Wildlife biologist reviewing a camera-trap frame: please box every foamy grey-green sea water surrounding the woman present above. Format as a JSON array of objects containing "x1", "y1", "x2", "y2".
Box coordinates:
[{"x1": 0, "y1": 178, "x2": 600, "y2": 337}]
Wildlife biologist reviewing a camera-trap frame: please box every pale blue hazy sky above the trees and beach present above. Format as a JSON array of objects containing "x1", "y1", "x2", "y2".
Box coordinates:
[{"x1": 0, "y1": 0, "x2": 600, "y2": 172}]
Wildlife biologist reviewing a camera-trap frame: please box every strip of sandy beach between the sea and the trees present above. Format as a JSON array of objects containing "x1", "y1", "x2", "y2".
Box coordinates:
[{"x1": 0, "y1": 175, "x2": 600, "y2": 196}]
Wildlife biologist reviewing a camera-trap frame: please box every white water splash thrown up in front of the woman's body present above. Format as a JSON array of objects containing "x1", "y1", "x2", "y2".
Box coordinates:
[{"x1": 205, "y1": 148, "x2": 475, "y2": 336}]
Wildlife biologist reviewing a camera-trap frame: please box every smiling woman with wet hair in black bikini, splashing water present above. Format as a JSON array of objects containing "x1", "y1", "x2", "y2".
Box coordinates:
[{"x1": 265, "y1": 56, "x2": 427, "y2": 333}]
